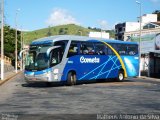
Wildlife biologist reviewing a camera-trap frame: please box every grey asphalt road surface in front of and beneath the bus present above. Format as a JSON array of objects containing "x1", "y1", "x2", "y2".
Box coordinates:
[{"x1": 0, "y1": 74, "x2": 160, "y2": 120}]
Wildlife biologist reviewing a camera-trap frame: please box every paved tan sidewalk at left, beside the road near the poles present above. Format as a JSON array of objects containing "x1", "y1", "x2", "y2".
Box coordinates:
[{"x1": 0, "y1": 70, "x2": 22, "y2": 85}]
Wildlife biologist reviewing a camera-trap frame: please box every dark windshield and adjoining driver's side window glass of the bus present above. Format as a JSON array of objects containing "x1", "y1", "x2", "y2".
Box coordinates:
[{"x1": 25, "y1": 45, "x2": 63, "y2": 71}]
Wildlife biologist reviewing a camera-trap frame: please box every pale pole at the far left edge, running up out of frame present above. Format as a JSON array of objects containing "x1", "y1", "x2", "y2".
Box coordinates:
[{"x1": 1, "y1": 0, "x2": 4, "y2": 80}]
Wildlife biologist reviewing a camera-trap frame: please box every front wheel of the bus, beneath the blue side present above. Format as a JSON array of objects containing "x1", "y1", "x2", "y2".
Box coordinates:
[{"x1": 67, "y1": 72, "x2": 76, "y2": 86}]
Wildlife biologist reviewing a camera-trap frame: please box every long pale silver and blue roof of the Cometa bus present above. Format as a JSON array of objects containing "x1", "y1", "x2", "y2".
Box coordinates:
[{"x1": 31, "y1": 35, "x2": 138, "y2": 45}]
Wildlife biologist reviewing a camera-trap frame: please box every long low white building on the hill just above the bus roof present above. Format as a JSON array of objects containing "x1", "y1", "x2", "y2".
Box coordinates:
[{"x1": 89, "y1": 32, "x2": 109, "y2": 39}]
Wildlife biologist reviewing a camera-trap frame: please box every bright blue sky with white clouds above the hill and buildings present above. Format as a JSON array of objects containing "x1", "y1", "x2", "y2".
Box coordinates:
[{"x1": 4, "y1": 0, "x2": 160, "y2": 31}]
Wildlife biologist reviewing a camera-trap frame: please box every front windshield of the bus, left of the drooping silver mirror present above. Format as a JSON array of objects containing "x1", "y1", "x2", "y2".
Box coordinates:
[{"x1": 25, "y1": 51, "x2": 49, "y2": 71}]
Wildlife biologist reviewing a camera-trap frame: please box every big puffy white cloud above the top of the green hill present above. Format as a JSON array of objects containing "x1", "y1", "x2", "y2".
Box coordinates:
[{"x1": 46, "y1": 8, "x2": 80, "y2": 26}]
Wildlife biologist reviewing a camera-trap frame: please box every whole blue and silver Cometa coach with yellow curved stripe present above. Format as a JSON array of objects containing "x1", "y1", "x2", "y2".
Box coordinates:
[{"x1": 24, "y1": 35, "x2": 139, "y2": 85}]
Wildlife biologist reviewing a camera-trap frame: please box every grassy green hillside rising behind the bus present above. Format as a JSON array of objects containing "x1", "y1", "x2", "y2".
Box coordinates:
[{"x1": 23, "y1": 24, "x2": 114, "y2": 44}]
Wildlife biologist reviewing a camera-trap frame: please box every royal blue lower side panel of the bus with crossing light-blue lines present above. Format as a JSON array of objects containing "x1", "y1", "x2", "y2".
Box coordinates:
[{"x1": 62, "y1": 55, "x2": 122, "y2": 81}]
